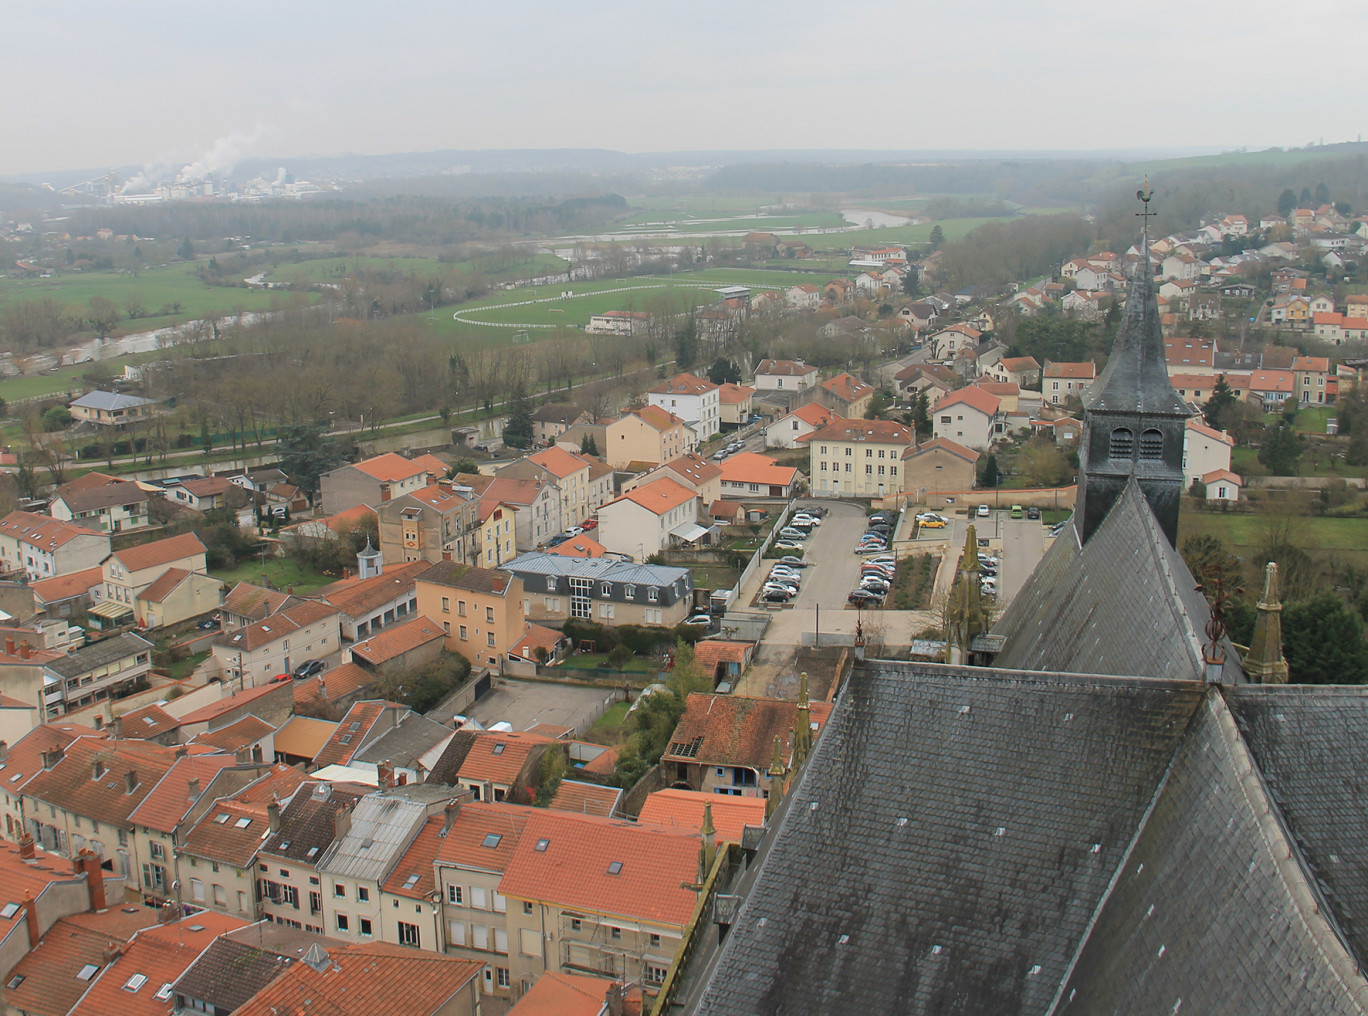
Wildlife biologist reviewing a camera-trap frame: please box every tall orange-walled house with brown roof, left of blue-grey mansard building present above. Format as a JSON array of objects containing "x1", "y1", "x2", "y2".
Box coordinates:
[{"x1": 415, "y1": 555, "x2": 522, "y2": 669}]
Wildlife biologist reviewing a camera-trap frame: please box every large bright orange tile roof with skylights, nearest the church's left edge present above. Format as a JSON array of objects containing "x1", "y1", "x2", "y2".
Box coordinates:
[{"x1": 499, "y1": 811, "x2": 702, "y2": 927}]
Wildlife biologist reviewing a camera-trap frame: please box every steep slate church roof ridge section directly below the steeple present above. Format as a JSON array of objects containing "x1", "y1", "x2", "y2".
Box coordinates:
[{"x1": 993, "y1": 480, "x2": 1245, "y2": 684}]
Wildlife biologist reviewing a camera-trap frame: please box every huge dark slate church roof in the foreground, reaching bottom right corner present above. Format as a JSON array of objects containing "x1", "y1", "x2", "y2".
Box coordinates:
[{"x1": 685, "y1": 662, "x2": 1368, "y2": 1016}]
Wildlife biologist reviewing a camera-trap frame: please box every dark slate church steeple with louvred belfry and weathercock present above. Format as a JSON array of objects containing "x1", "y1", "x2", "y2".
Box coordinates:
[{"x1": 1075, "y1": 186, "x2": 1192, "y2": 544}]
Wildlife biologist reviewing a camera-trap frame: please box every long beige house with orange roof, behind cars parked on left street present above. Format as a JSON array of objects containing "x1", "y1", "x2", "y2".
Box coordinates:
[{"x1": 211, "y1": 600, "x2": 342, "y2": 689}]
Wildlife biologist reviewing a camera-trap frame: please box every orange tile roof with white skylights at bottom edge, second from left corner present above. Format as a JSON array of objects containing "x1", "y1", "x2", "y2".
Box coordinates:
[{"x1": 70, "y1": 911, "x2": 246, "y2": 1016}]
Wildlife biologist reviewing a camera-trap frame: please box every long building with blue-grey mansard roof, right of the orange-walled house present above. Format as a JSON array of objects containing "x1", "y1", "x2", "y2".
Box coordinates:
[{"x1": 505, "y1": 554, "x2": 694, "y2": 628}]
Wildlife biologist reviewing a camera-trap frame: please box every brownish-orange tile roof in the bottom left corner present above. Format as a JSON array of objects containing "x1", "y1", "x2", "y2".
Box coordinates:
[{"x1": 5, "y1": 907, "x2": 160, "y2": 1016}]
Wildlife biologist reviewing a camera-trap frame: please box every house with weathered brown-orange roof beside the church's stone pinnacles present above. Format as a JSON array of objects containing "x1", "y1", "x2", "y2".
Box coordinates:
[{"x1": 661, "y1": 692, "x2": 832, "y2": 797}]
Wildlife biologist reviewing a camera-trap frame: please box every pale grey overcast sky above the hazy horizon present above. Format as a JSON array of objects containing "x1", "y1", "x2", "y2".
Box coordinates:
[{"x1": 0, "y1": 0, "x2": 1368, "y2": 174}]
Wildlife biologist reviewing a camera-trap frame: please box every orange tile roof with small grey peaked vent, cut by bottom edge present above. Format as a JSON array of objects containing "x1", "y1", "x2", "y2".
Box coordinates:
[{"x1": 234, "y1": 942, "x2": 484, "y2": 1016}]
